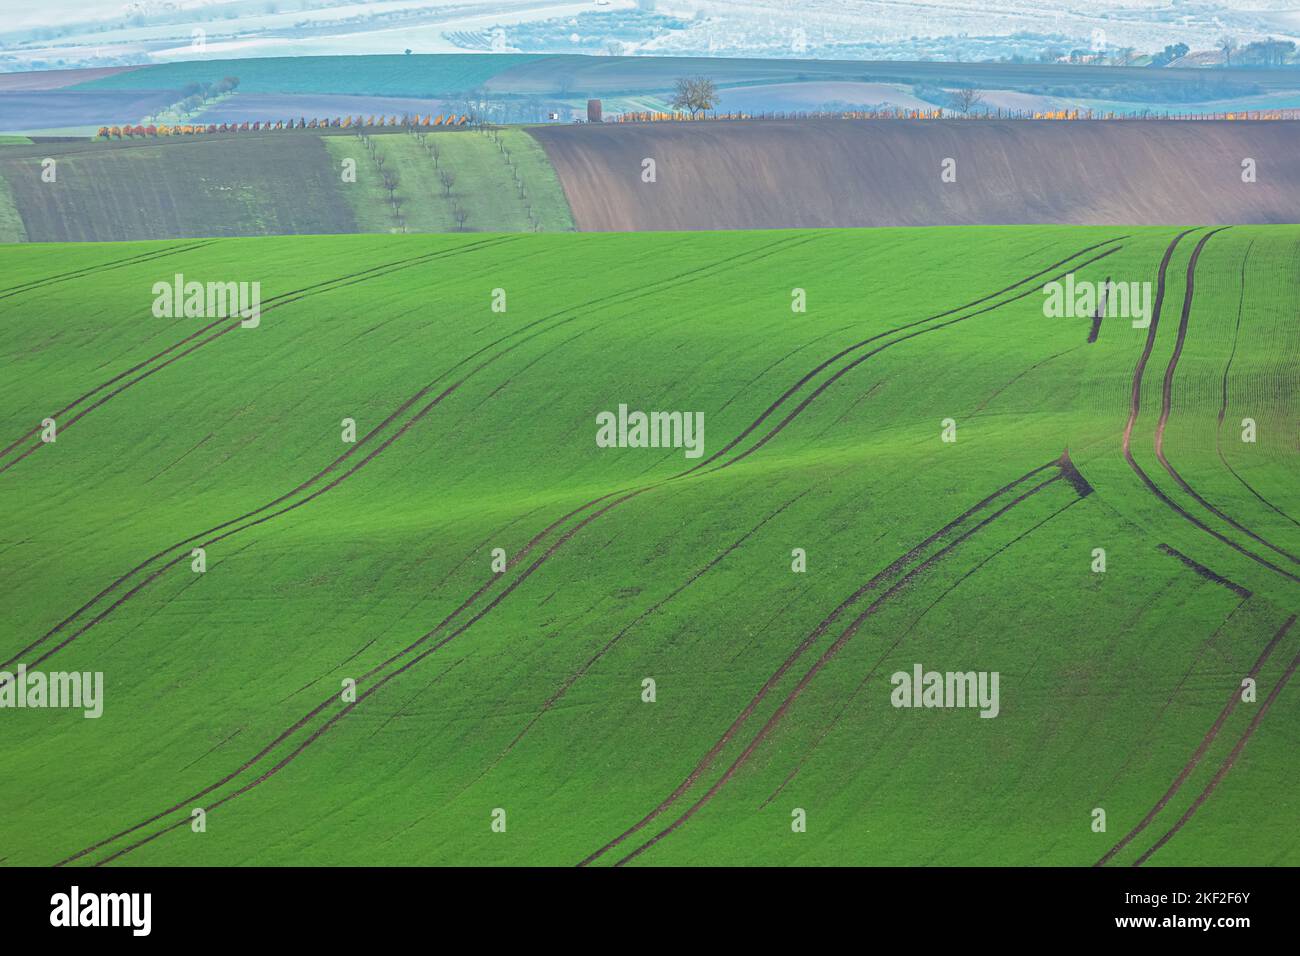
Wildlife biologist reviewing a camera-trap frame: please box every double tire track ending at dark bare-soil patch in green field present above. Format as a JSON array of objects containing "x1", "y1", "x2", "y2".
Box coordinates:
[{"x1": 579, "y1": 462, "x2": 1060, "y2": 866}]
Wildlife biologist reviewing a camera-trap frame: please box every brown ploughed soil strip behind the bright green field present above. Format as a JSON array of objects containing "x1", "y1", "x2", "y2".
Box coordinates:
[{"x1": 532, "y1": 120, "x2": 1300, "y2": 232}]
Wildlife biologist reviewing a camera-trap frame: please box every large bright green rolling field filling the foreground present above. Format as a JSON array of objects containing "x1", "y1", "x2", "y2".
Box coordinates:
[{"x1": 0, "y1": 226, "x2": 1300, "y2": 865}]
